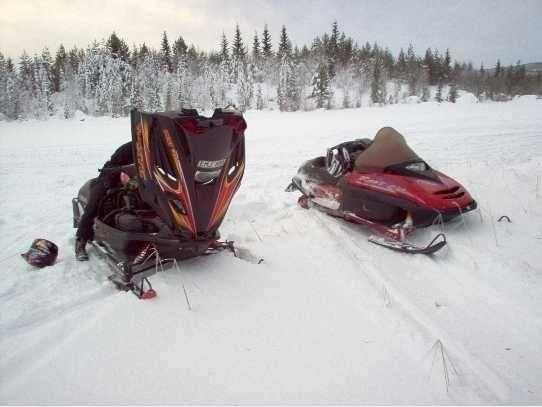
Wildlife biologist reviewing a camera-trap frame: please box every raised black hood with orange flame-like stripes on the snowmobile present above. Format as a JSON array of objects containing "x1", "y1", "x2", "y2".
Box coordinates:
[{"x1": 131, "y1": 109, "x2": 246, "y2": 239}]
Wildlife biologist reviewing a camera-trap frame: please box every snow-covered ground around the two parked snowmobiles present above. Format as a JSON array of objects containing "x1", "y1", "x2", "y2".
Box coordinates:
[{"x1": 0, "y1": 98, "x2": 542, "y2": 404}]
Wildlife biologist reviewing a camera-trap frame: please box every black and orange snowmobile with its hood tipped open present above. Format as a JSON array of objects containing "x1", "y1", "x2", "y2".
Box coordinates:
[{"x1": 72, "y1": 109, "x2": 247, "y2": 298}]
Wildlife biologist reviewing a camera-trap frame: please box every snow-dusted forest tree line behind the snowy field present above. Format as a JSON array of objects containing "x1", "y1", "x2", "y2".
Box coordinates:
[{"x1": 0, "y1": 22, "x2": 542, "y2": 120}]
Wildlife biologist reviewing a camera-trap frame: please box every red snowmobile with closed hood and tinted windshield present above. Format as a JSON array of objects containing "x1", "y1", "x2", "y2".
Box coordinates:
[{"x1": 286, "y1": 127, "x2": 477, "y2": 254}]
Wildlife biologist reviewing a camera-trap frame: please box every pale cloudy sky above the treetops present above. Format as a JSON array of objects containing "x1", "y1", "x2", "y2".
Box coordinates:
[{"x1": 0, "y1": 0, "x2": 542, "y2": 65}]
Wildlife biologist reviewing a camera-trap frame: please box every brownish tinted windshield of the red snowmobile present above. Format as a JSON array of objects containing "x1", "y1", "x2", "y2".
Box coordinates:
[{"x1": 354, "y1": 127, "x2": 425, "y2": 172}]
